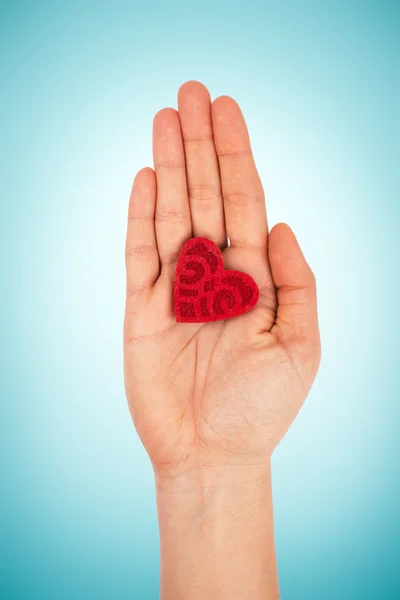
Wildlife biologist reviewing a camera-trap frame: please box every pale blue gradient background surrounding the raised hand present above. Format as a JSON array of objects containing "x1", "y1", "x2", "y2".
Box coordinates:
[{"x1": 0, "y1": 0, "x2": 400, "y2": 600}]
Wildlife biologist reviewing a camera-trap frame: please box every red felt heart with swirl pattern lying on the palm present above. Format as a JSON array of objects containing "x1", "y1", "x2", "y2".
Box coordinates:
[{"x1": 174, "y1": 237, "x2": 259, "y2": 323}]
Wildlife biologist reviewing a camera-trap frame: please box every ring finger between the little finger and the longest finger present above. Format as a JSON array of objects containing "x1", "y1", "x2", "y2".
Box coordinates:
[{"x1": 153, "y1": 108, "x2": 192, "y2": 274}]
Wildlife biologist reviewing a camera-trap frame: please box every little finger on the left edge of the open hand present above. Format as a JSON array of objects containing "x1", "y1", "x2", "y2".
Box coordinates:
[{"x1": 125, "y1": 167, "x2": 159, "y2": 308}]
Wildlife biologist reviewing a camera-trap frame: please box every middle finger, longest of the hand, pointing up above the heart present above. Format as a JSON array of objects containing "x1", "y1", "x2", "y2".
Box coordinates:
[{"x1": 178, "y1": 81, "x2": 226, "y2": 248}]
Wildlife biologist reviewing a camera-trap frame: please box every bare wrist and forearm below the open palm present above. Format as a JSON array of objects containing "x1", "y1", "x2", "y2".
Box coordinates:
[{"x1": 156, "y1": 467, "x2": 279, "y2": 600}]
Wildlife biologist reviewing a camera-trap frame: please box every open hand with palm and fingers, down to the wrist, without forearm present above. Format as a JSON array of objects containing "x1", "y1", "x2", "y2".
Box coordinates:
[{"x1": 124, "y1": 82, "x2": 320, "y2": 477}]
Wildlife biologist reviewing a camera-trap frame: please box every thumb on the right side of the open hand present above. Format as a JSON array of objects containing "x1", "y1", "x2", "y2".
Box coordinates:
[{"x1": 268, "y1": 223, "x2": 320, "y2": 364}]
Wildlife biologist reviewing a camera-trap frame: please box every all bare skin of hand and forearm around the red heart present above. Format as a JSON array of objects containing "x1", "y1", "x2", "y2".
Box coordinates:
[{"x1": 124, "y1": 81, "x2": 320, "y2": 600}]
